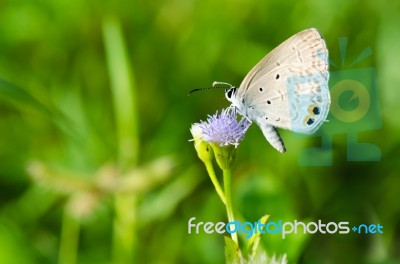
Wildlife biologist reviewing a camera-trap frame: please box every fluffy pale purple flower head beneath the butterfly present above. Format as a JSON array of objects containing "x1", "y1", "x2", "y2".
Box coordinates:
[{"x1": 200, "y1": 108, "x2": 251, "y2": 147}]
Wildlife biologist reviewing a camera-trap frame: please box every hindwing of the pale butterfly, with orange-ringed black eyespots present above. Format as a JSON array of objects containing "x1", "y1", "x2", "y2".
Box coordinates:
[{"x1": 244, "y1": 65, "x2": 330, "y2": 134}]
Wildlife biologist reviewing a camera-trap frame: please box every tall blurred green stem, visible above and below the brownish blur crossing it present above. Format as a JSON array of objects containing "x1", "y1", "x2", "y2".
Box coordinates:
[{"x1": 103, "y1": 17, "x2": 139, "y2": 263}]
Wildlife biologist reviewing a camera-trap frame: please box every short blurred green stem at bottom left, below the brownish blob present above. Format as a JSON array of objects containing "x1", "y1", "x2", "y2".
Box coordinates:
[{"x1": 58, "y1": 208, "x2": 80, "y2": 264}]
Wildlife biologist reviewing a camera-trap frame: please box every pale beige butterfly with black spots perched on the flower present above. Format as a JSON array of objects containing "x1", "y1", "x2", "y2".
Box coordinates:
[{"x1": 223, "y1": 28, "x2": 330, "y2": 153}]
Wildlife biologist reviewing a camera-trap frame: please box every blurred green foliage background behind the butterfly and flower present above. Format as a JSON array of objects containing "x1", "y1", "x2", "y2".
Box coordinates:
[{"x1": 0, "y1": 0, "x2": 400, "y2": 263}]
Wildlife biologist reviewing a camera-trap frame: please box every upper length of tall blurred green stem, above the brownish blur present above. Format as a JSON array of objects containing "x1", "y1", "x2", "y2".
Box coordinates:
[{"x1": 103, "y1": 14, "x2": 139, "y2": 169}]
